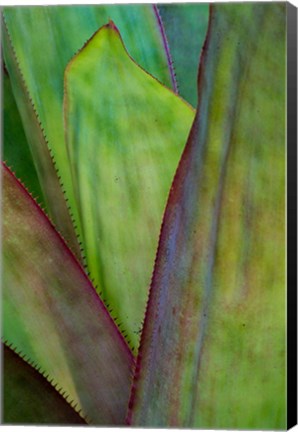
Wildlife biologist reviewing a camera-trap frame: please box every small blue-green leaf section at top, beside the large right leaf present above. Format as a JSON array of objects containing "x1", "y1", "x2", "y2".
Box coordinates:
[{"x1": 158, "y1": 3, "x2": 209, "y2": 106}]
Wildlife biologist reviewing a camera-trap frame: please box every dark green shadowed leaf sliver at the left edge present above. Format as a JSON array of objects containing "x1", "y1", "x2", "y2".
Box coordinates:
[{"x1": 2, "y1": 72, "x2": 45, "y2": 206}]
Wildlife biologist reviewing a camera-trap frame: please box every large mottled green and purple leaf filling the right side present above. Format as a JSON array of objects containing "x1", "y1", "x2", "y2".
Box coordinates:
[{"x1": 128, "y1": 3, "x2": 286, "y2": 429}]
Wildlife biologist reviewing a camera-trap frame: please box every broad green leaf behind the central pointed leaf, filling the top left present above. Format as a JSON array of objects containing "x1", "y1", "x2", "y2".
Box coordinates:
[{"x1": 4, "y1": 5, "x2": 171, "y2": 248}]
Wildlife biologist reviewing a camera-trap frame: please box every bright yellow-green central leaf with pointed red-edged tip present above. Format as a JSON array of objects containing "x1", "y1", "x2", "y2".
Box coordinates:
[{"x1": 64, "y1": 22, "x2": 194, "y2": 346}]
